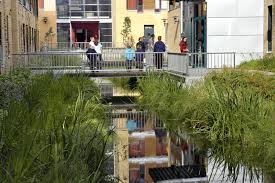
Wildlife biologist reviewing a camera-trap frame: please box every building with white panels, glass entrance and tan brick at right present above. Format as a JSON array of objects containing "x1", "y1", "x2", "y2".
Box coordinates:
[{"x1": 168, "y1": 0, "x2": 264, "y2": 65}]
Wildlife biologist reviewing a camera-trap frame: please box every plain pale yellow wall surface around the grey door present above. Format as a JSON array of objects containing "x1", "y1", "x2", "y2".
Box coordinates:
[{"x1": 112, "y1": 0, "x2": 168, "y2": 47}]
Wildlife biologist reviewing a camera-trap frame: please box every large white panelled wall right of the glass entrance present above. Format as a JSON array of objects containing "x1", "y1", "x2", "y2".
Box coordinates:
[{"x1": 207, "y1": 0, "x2": 264, "y2": 64}]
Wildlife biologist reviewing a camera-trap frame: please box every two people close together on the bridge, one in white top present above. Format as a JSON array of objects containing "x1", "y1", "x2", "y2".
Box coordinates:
[{"x1": 86, "y1": 37, "x2": 102, "y2": 70}]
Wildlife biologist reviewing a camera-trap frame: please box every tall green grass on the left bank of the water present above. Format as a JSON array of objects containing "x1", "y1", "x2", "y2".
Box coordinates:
[{"x1": 0, "y1": 74, "x2": 113, "y2": 183}]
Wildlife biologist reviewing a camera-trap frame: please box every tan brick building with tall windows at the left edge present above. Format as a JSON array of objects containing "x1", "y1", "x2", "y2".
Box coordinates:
[{"x1": 0, "y1": 0, "x2": 38, "y2": 73}]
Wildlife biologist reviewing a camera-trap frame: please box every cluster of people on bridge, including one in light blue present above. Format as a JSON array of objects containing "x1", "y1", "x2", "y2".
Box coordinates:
[{"x1": 124, "y1": 34, "x2": 166, "y2": 69}]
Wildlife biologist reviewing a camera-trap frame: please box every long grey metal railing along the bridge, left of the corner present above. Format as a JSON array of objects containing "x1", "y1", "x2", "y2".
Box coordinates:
[{"x1": 10, "y1": 52, "x2": 167, "y2": 72}]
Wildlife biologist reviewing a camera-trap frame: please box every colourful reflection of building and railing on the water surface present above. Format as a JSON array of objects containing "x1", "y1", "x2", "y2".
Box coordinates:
[{"x1": 113, "y1": 110, "x2": 169, "y2": 183}]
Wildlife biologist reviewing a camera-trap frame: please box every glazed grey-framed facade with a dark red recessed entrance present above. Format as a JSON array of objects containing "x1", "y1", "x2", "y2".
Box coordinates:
[{"x1": 56, "y1": 0, "x2": 113, "y2": 47}]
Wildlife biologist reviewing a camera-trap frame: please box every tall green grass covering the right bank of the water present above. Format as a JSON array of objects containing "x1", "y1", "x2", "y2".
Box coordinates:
[{"x1": 139, "y1": 70, "x2": 275, "y2": 182}]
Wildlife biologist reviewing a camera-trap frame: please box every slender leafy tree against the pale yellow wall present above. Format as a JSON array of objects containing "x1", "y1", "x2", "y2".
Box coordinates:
[{"x1": 120, "y1": 17, "x2": 134, "y2": 47}]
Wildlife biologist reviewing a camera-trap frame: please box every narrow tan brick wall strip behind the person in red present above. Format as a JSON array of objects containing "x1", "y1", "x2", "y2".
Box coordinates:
[{"x1": 167, "y1": 8, "x2": 181, "y2": 53}]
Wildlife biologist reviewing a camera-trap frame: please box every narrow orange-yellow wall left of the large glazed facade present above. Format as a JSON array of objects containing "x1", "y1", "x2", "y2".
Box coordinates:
[{"x1": 38, "y1": 0, "x2": 57, "y2": 48}]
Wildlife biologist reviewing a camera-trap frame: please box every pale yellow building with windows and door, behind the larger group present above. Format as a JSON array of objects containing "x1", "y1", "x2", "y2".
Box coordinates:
[{"x1": 112, "y1": 0, "x2": 169, "y2": 47}]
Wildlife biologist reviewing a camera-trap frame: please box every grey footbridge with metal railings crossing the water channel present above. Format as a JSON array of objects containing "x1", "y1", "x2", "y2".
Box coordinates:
[{"x1": 8, "y1": 50, "x2": 260, "y2": 77}]
